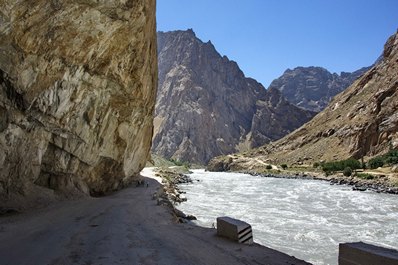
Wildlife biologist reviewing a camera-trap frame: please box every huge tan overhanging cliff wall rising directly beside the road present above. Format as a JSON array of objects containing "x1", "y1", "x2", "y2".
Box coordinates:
[{"x1": 0, "y1": 0, "x2": 157, "y2": 204}]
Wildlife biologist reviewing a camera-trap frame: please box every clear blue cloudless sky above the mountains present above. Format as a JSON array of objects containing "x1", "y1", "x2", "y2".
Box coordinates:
[{"x1": 157, "y1": 0, "x2": 398, "y2": 87}]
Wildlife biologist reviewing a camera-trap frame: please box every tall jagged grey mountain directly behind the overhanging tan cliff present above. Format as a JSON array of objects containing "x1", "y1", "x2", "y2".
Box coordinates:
[{"x1": 152, "y1": 30, "x2": 314, "y2": 164}]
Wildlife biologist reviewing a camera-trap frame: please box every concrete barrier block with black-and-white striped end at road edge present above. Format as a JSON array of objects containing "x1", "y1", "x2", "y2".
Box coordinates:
[{"x1": 217, "y1": 216, "x2": 253, "y2": 244}]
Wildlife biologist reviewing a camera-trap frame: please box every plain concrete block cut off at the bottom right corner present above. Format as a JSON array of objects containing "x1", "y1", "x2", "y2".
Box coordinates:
[{"x1": 339, "y1": 242, "x2": 398, "y2": 265}]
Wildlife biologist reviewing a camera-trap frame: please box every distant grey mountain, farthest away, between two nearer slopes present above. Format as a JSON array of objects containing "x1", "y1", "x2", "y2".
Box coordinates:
[{"x1": 270, "y1": 67, "x2": 371, "y2": 112}]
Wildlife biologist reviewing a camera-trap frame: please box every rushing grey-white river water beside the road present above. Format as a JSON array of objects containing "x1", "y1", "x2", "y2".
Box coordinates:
[{"x1": 178, "y1": 170, "x2": 398, "y2": 264}]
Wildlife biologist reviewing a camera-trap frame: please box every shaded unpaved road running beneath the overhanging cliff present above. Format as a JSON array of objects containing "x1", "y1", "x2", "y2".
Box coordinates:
[{"x1": 0, "y1": 167, "x2": 307, "y2": 265}]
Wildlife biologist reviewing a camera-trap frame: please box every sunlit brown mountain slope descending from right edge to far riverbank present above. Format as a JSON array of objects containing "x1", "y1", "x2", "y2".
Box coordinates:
[{"x1": 209, "y1": 33, "x2": 398, "y2": 169}]
